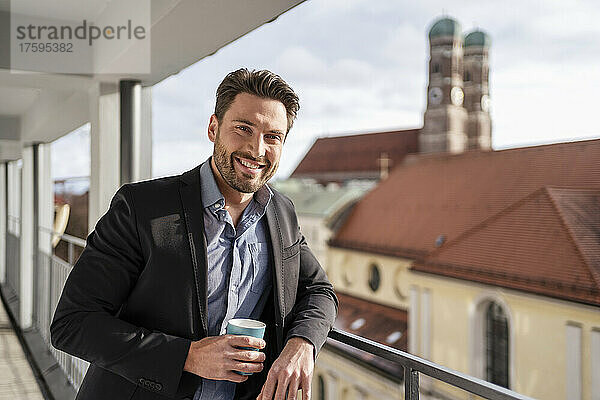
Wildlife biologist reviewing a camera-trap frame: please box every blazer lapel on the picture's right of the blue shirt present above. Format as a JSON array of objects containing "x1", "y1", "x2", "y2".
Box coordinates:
[{"x1": 266, "y1": 196, "x2": 285, "y2": 349}]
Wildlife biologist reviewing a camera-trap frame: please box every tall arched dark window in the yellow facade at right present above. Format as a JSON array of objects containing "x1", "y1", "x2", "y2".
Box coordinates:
[{"x1": 485, "y1": 302, "x2": 509, "y2": 388}]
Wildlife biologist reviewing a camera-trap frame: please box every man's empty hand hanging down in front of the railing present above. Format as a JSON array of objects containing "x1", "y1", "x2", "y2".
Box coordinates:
[{"x1": 257, "y1": 337, "x2": 315, "y2": 400}]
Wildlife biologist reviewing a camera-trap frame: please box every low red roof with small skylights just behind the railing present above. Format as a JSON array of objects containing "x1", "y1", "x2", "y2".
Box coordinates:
[{"x1": 327, "y1": 292, "x2": 408, "y2": 380}]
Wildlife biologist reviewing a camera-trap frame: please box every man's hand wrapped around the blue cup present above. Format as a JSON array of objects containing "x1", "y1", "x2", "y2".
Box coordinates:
[{"x1": 183, "y1": 335, "x2": 266, "y2": 383}]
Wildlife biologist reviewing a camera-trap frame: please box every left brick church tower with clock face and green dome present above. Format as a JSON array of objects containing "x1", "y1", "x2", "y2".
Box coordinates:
[{"x1": 419, "y1": 17, "x2": 468, "y2": 153}]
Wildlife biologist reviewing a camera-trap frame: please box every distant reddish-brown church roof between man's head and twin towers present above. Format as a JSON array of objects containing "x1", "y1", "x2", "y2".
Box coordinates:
[{"x1": 291, "y1": 129, "x2": 420, "y2": 178}]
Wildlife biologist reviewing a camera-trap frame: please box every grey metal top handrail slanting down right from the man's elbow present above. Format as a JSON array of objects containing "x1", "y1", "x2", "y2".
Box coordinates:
[{"x1": 329, "y1": 328, "x2": 533, "y2": 400}]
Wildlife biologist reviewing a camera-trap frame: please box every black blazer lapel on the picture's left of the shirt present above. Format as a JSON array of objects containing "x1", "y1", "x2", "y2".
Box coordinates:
[{"x1": 179, "y1": 166, "x2": 208, "y2": 337}]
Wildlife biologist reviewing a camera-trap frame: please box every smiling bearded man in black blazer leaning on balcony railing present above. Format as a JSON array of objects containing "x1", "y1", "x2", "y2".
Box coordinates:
[{"x1": 50, "y1": 69, "x2": 338, "y2": 400}]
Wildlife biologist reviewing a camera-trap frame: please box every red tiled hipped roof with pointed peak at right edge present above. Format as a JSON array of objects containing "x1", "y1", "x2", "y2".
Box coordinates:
[{"x1": 412, "y1": 187, "x2": 600, "y2": 305}]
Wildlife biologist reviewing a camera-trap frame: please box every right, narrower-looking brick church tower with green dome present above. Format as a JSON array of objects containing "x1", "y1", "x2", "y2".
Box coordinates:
[{"x1": 463, "y1": 30, "x2": 492, "y2": 150}]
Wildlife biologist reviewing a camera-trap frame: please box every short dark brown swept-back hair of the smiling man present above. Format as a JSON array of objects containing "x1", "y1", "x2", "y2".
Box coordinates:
[{"x1": 215, "y1": 68, "x2": 300, "y2": 136}]
